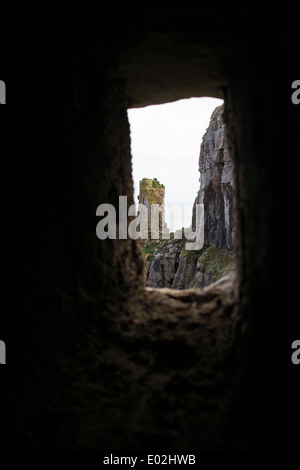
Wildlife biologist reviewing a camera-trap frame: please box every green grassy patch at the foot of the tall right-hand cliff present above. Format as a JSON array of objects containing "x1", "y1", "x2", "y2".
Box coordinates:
[{"x1": 198, "y1": 244, "x2": 235, "y2": 281}]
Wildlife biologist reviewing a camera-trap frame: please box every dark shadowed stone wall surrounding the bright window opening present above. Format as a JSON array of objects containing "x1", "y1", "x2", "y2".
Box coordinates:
[{"x1": 0, "y1": 6, "x2": 300, "y2": 450}]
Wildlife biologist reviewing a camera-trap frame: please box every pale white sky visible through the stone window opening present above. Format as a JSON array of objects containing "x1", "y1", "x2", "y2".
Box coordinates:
[{"x1": 128, "y1": 97, "x2": 223, "y2": 229}]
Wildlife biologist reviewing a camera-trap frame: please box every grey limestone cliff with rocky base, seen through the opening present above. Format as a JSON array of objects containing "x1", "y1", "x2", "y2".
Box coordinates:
[{"x1": 144, "y1": 105, "x2": 235, "y2": 289}]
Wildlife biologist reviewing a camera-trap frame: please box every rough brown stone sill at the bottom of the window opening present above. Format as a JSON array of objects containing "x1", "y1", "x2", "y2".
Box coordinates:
[{"x1": 109, "y1": 273, "x2": 239, "y2": 356}]
